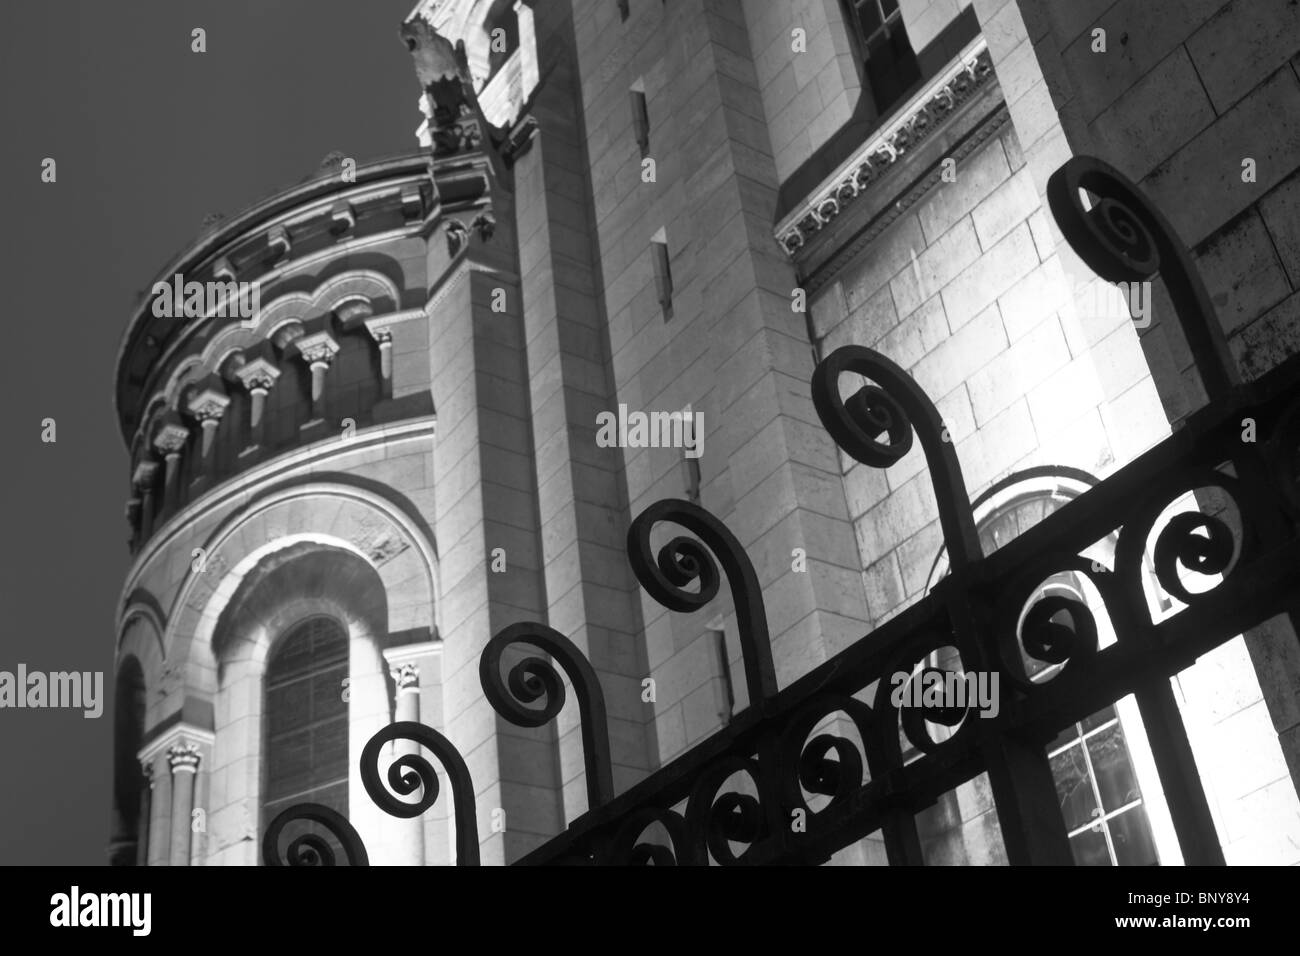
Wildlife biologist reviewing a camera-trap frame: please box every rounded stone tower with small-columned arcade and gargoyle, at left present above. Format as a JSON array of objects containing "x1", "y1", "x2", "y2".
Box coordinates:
[{"x1": 111, "y1": 4, "x2": 608, "y2": 865}]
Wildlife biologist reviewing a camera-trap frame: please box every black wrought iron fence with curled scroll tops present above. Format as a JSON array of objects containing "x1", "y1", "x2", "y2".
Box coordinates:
[{"x1": 263, "y1": 157, "x2": 1300, "y2": 865}]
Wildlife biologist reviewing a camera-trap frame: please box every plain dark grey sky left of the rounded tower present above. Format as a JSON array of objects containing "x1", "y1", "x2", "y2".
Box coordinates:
[{"x1": 0, "y1": 0, "x2": 421, "y2": 864}]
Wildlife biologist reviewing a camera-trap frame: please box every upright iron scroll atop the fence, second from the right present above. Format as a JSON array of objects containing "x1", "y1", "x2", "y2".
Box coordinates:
[{"x1": 813, "y1": 345, "x2": 980, "y2": 574}]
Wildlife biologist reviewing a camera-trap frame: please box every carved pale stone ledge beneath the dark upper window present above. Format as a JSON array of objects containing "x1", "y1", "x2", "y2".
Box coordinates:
[{"x1": 775, "y1": 36, "x2": 995, "y2": 259}]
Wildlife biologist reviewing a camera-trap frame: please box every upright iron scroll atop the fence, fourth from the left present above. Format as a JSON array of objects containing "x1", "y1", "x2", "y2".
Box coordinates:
[{"x1": 628, "y1": 498, "x2": 777, "y2": 708}]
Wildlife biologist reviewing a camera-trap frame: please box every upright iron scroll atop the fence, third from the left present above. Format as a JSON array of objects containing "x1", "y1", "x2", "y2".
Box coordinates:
[{"x1": 478, "y1": 624, "x2": 616, "y2": 809}]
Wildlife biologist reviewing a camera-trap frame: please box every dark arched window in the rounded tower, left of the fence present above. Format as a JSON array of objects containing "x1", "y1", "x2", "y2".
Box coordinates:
[{"x1": 261, "y1": 617, "x2": 348, "y2": 827}]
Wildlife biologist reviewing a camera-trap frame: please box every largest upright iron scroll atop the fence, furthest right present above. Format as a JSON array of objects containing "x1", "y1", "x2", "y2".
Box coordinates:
[{"x1": 1048, "y1": 156, "x2": 1238, "y2": 402}]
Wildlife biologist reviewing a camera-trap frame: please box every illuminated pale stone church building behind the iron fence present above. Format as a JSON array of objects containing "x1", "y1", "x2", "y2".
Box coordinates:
[{"x1": 111, "y1": 0, "x2": 1300, "y2": 865}]
